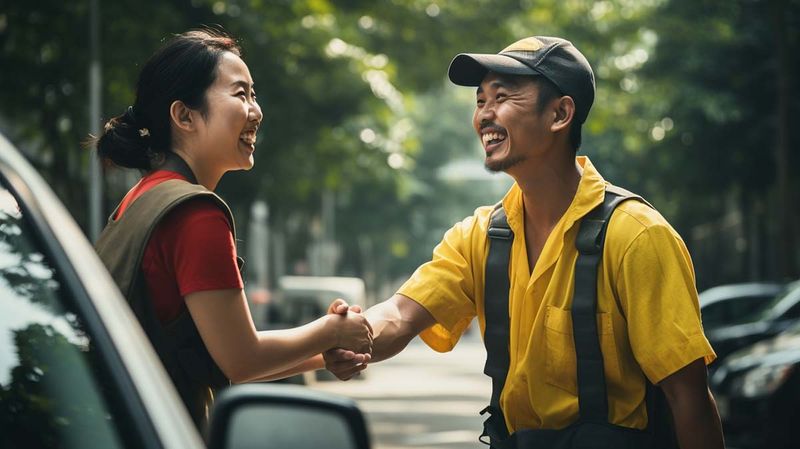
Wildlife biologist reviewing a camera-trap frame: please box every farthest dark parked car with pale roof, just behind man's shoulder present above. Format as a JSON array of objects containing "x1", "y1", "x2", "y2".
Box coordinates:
[{"x1": 699, "y1": 282, "x2": 784, "y2": 331}]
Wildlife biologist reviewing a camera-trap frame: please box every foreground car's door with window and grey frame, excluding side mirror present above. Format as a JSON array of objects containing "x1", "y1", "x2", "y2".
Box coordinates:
[{"x1": 0, "y1": 136, "x2": 202, "y2": 449}]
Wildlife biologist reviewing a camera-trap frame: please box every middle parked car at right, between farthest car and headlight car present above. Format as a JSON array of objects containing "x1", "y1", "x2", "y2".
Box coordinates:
[{"x1": 706, "y1": 281, "x2": 800, "y2": 371}]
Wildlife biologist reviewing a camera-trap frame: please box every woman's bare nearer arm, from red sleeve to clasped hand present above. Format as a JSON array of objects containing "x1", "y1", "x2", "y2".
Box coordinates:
[{"x1": 185, "y1": 289, "x2": 372, "y2": 383}]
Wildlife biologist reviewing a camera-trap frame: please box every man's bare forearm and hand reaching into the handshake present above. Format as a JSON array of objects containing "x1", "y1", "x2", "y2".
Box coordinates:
[{"x1": 323, "y1": 294, "x2": 436, "y2": 380}]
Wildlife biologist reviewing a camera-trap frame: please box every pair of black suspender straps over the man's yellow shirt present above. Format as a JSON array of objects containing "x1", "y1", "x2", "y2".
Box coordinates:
[{"x1": 481, "y1": 186, "x2": 652, "y2": 447}]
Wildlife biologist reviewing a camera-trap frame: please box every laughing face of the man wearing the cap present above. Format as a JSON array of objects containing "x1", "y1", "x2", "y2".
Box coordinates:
[{"x1": 472, "y1": 72, "x2": 550, "y2": 172}]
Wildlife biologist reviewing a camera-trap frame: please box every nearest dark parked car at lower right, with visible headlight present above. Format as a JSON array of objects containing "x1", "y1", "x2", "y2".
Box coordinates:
[{"x1": 710, "y1": 322, "x2": 800, "y2": 449}]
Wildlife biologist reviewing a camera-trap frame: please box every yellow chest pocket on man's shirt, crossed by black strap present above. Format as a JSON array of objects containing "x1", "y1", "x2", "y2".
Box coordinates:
[{"x1": 545, "y1": 306, "x2": 622, "y2": 395}]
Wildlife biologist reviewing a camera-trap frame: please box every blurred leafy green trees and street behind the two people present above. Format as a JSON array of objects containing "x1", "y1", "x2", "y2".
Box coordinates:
[{"x1": 0, "y1": 0, "x2": 800, "y2": 447}]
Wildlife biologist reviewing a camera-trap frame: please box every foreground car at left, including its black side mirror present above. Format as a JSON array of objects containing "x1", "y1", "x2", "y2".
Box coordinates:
[{"x1": 0, "y1": 135, "x2": 369, "y2": 449}]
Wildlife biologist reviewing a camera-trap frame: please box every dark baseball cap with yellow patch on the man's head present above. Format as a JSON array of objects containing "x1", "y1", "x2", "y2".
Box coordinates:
[{"x1": 447, "y1": 36, "x2": 594, "y2": 123}]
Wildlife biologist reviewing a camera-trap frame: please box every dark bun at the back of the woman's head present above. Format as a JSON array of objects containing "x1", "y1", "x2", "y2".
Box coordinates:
[{"x1": 97, "y1": 108, "x2": 151, "y2": 170}]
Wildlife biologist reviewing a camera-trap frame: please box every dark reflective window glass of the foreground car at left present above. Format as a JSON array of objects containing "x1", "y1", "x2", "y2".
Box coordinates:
[{"x1": 0, "y1": 185, "x2": 138, "y2": 449}]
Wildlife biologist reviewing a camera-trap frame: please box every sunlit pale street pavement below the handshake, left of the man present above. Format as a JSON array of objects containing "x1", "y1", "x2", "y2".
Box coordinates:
[{"x1": 309, "y1": 326, "x2": 491, "y2": 449}]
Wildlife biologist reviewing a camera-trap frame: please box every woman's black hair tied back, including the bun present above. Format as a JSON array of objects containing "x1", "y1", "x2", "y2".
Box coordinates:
[{"x1": 93, "y1": 28, "x2": 241, "y2": 170}]
